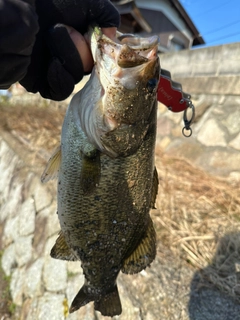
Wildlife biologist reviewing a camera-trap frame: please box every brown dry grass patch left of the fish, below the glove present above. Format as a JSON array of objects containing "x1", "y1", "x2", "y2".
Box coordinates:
[{"x1": 0, "y1": 102, "x2": 66, "y2": 156}]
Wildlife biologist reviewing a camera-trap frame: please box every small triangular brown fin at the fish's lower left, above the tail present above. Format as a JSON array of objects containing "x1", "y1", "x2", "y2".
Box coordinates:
[{"x1": 50, "y1": 231, "x2": 78, "y2": 261}]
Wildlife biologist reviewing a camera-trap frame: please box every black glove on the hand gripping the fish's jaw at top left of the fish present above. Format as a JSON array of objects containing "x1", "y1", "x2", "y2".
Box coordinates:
[{"x1": 20, "y1": 0, "x2": 120, "y2": 100}]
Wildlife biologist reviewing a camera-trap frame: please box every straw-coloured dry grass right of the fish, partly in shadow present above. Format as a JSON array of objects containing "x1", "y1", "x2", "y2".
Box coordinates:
[{"x1": 152, "y1": 151, "x2": 240, "y2": 301}]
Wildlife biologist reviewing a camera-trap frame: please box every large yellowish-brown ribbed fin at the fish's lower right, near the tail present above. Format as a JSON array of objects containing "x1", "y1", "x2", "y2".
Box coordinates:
[{"x1": 121, "y1": 219, "x2": 156, "y2": 274}]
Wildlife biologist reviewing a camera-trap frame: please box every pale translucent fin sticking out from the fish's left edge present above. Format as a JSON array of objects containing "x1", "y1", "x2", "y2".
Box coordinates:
[{"x1": 41, "y1": 146, "x2": 61, "y2": 183}]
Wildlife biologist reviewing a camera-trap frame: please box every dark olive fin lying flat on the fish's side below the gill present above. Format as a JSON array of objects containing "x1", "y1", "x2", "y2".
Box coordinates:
[{"x1": 80, "y1": 150, "x2": 101, "y2": 195}]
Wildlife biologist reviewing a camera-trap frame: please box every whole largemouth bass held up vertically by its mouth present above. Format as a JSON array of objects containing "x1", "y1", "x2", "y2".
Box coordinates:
[{"x1": 42, "y1": 27, "x2": 160, "y2": 316}]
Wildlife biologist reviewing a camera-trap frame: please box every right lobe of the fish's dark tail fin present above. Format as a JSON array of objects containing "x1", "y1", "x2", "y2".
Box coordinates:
[{"x1": 94, "y1": 285, "x2": 122, "y2": 317}]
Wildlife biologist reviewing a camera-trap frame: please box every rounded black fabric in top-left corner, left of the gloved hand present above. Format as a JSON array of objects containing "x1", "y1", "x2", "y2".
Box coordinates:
[{"x1": 0, "y1": 0, "x2": 38, "y2": 89}]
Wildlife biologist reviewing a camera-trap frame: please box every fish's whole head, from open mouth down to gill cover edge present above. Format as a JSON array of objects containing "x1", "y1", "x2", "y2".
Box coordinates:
[{"x1": 79, "y1": 27, "x2": 160, "y2": 157}]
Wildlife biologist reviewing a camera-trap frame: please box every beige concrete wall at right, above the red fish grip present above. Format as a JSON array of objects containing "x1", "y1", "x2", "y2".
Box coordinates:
[{"x1": 160, "y1": 43, "x2": 240, "y2": 95}]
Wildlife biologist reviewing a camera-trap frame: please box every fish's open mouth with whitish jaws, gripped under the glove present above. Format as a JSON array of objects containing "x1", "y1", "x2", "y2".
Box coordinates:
[{"x1": 91, "y1": 27, "x2": 159, "y2": 96}]
